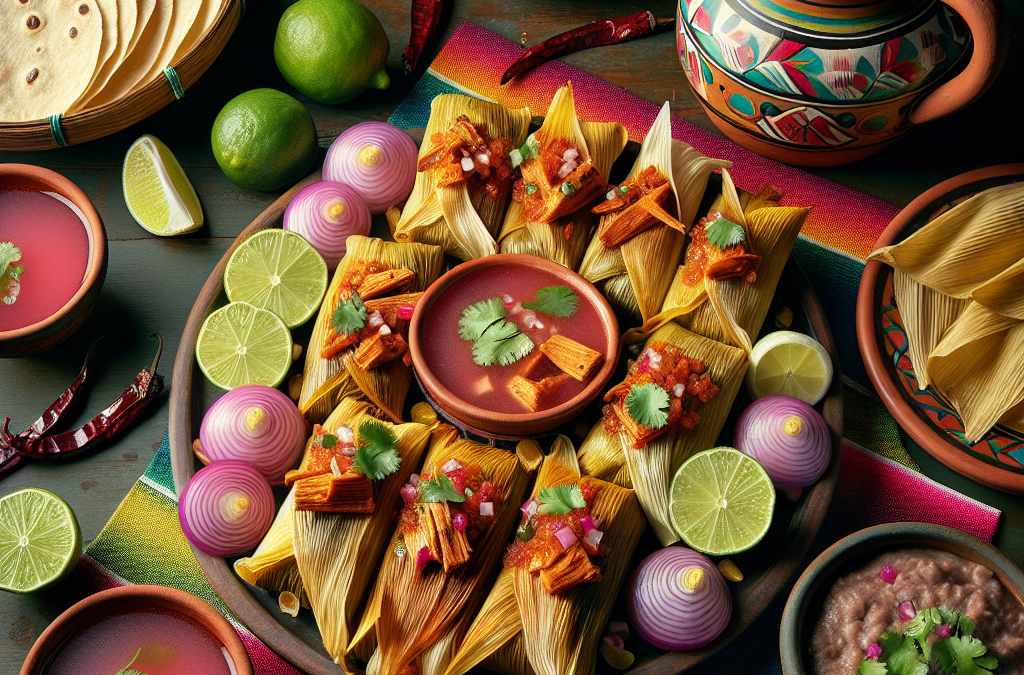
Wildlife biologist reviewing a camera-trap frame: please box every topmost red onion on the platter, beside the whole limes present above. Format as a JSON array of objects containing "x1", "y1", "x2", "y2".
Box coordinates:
[{"x1": 324, "y1": 122, "x2": 419, "y2": 214}]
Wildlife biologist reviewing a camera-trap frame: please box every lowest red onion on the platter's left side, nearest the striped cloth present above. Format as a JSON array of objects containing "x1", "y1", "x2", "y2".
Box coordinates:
[{"x1": 178, "y1": 460, "x2": 275, "y2": 556}]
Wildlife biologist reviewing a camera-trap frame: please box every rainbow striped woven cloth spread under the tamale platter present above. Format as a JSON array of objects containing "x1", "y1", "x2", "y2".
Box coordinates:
[{"x1": 76, "y1": 24, "x2": 999, "y2": 675}]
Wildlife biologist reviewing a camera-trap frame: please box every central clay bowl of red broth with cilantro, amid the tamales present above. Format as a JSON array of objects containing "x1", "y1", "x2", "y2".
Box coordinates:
[{"x1": 409, "y1": 253, "x2": 618, "y2": 438}]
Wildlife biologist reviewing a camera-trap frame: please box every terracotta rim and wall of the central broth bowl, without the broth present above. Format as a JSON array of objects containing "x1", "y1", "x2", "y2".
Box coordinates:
[{"x1": 409, "y1": 253, "x2": 618, "y2": 438}]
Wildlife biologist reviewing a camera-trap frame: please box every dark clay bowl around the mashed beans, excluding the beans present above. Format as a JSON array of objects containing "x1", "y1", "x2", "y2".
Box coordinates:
[{"x1": 779, "y1": 522, "x2": 1024, "y2": 675}]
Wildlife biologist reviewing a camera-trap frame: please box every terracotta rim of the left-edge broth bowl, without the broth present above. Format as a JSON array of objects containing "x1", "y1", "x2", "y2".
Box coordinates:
[{"x1": 0, "y1": 164, "x2": 106, "y2": 357}]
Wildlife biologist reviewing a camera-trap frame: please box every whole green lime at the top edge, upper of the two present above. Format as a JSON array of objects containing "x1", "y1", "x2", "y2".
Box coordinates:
[{"x1": 273, "y1": 0, "x2": 391, "y2": 104}]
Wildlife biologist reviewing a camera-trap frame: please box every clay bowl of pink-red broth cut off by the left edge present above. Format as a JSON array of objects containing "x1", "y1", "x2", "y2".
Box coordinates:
[{"x1": 0, "y1": 164, "x2": 107, "y2": 358}]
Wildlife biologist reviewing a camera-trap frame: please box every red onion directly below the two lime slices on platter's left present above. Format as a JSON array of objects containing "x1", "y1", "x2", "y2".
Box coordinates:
[{"x1": 199, "y1": 384, "x2": 306, "y2": 484}]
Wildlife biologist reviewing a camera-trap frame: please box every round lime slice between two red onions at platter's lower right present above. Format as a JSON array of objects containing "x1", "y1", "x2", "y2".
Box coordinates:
[{"x1": 669, "y1": 448, "x2": 775, "y2": 555}]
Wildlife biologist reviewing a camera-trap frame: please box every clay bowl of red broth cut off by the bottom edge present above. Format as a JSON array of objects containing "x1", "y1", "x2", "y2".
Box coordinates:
[{"x1": 20, "y1": 586, "x2": 253, "y2": 675}]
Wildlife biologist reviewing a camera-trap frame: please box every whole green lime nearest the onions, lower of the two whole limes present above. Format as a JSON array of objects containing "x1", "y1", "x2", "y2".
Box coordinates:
[{"x1": 210, "y1": 89, "x2": 316, "y2": 192}]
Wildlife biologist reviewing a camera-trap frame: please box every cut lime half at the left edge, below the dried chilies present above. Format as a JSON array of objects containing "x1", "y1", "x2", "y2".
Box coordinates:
[{"x1": 0, "y1": 488, "x2": 82, "y2": 593}]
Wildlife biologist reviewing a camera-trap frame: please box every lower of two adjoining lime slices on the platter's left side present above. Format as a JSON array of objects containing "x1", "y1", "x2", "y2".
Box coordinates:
[{"x1": 196, "y1": 302, "x2": 292, "y2": 389}]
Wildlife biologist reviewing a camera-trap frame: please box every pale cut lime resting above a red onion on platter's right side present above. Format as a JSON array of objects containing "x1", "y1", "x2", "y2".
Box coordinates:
[{"x1": 746, "y1": 331, "x2": 833, "y2": 406}]
